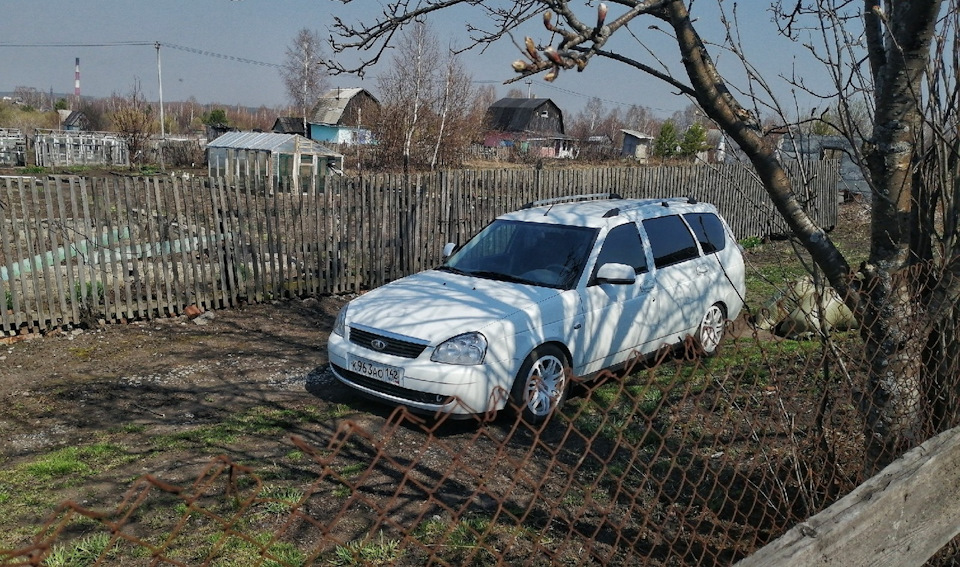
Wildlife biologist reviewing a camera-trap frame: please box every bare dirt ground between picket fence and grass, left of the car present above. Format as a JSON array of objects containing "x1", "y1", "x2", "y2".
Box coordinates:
[{"x1": 0, "y1": 297, "x2": 348, "y2": 460}]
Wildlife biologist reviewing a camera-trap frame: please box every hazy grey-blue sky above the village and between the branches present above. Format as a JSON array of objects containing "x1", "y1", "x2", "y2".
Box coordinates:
[{"x1": 0, "y1": 0, "x2": 819, "y2": 117}]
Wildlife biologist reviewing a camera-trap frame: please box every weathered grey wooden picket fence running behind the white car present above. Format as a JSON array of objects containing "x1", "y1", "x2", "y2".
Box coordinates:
[{"x1": 0, "y1": 162, "x2": 837, "y2": 334}]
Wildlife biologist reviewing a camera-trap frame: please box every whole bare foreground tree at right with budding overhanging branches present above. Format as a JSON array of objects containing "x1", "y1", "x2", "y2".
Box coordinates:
[{"x1": 334, "y1": 0, "x2": 960, "y2": 472}]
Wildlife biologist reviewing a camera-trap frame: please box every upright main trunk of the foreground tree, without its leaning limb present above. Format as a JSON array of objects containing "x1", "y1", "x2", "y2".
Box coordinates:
[{"x1": 860, "y1": 0, "x2": 941, "y2": 474}]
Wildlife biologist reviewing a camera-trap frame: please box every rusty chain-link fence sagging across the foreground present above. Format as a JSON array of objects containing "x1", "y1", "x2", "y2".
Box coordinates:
[{"x1": 0, "y1": 308, "x2": 957, "y2": 565}]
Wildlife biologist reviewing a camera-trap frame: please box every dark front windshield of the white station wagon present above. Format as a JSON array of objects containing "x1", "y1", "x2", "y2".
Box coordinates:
[{"x1": 439, "y1": 220, "x2": 597, "y2": 289}]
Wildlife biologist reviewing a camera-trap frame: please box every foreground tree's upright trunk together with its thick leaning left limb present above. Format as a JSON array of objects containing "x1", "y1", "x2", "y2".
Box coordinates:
[{"x1": 658, "y1": 0, "x2": 941, "y2": 474}]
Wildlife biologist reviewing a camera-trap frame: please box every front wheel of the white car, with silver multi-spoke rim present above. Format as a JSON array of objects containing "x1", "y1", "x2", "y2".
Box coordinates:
[{"x1": 510, "y1": 345, "x2": 570, "y2": 425}]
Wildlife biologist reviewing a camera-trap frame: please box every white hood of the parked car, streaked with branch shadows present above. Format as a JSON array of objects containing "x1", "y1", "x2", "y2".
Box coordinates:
[{"x1": 347, "y1": 270, "x2": 562, "y2": 345}]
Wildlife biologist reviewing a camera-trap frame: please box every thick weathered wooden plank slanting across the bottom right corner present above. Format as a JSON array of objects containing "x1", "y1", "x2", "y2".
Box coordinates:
[{"x1": 737, "y1": 428, "x2": 960, "y2": 567}]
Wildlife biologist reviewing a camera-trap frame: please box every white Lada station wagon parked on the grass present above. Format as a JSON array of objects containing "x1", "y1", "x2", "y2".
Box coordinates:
[{"x1": 328, "y1": 195, "x2": 744, "y2": 423}]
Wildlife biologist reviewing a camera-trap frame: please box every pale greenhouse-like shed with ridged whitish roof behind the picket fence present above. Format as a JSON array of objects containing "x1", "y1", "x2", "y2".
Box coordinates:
[{"x1": 207, "y1": 132, "x2": 343, "y2": 190}]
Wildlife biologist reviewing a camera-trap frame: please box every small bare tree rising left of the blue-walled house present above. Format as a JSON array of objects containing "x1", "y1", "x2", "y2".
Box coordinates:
[{"x1": 280, "y1": 28, "x2": 327, "y2": 131}]
